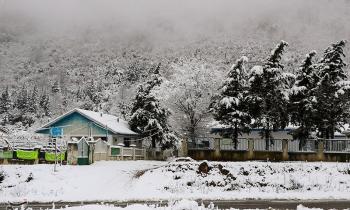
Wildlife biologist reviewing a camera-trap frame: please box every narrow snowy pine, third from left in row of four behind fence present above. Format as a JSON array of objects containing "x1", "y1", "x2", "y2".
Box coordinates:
[{"x1": 289, "y1": 50, "x2": 319, "y2": 150}]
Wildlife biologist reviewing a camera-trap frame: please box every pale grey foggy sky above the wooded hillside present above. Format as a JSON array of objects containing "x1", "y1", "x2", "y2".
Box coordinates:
[{"x1": 0, "y1": 0, "x2": 350, "y2": 48}]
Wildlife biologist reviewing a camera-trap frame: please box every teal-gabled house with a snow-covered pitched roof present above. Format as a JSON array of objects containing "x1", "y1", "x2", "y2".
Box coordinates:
[{"x1": 35, "y1": 108, "x2": 142, "y2": 147}]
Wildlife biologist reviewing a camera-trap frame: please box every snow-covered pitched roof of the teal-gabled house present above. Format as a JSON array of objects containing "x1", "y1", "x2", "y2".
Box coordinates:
[{"x1": 37, "y1": 108, "x2": 137, "y2": 135}]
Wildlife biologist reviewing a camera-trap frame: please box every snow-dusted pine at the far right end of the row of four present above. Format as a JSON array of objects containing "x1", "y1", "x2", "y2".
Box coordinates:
[{"x1": 314, "y1": 40, "x2": 350, "y2": 139}]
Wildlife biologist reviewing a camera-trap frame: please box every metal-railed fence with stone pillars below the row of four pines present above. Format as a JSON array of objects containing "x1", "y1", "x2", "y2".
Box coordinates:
[{"x1": 186, "y1": 138, "x2": 350, "y2": 162}]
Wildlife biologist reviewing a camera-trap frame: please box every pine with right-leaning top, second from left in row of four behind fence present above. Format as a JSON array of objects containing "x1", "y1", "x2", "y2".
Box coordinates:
[{"x1": 248, "y1": 40, "x2": 289, "y2": 150}]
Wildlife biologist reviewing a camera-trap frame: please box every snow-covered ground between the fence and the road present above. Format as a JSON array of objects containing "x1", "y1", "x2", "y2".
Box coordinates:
[{"x1": 0, "y1": 161, "x2": 350, "y2": 202}]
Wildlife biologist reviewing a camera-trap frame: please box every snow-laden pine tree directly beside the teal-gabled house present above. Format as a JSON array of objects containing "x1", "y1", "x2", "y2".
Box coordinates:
[{"x1": 129, "y1": 66, "x2": 177, "y2": 149}]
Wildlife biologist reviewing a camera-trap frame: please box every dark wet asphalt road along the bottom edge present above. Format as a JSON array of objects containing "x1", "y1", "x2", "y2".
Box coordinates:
[{"x1": 0, "y1": 200, "x2": 350, "y2": 210}]
